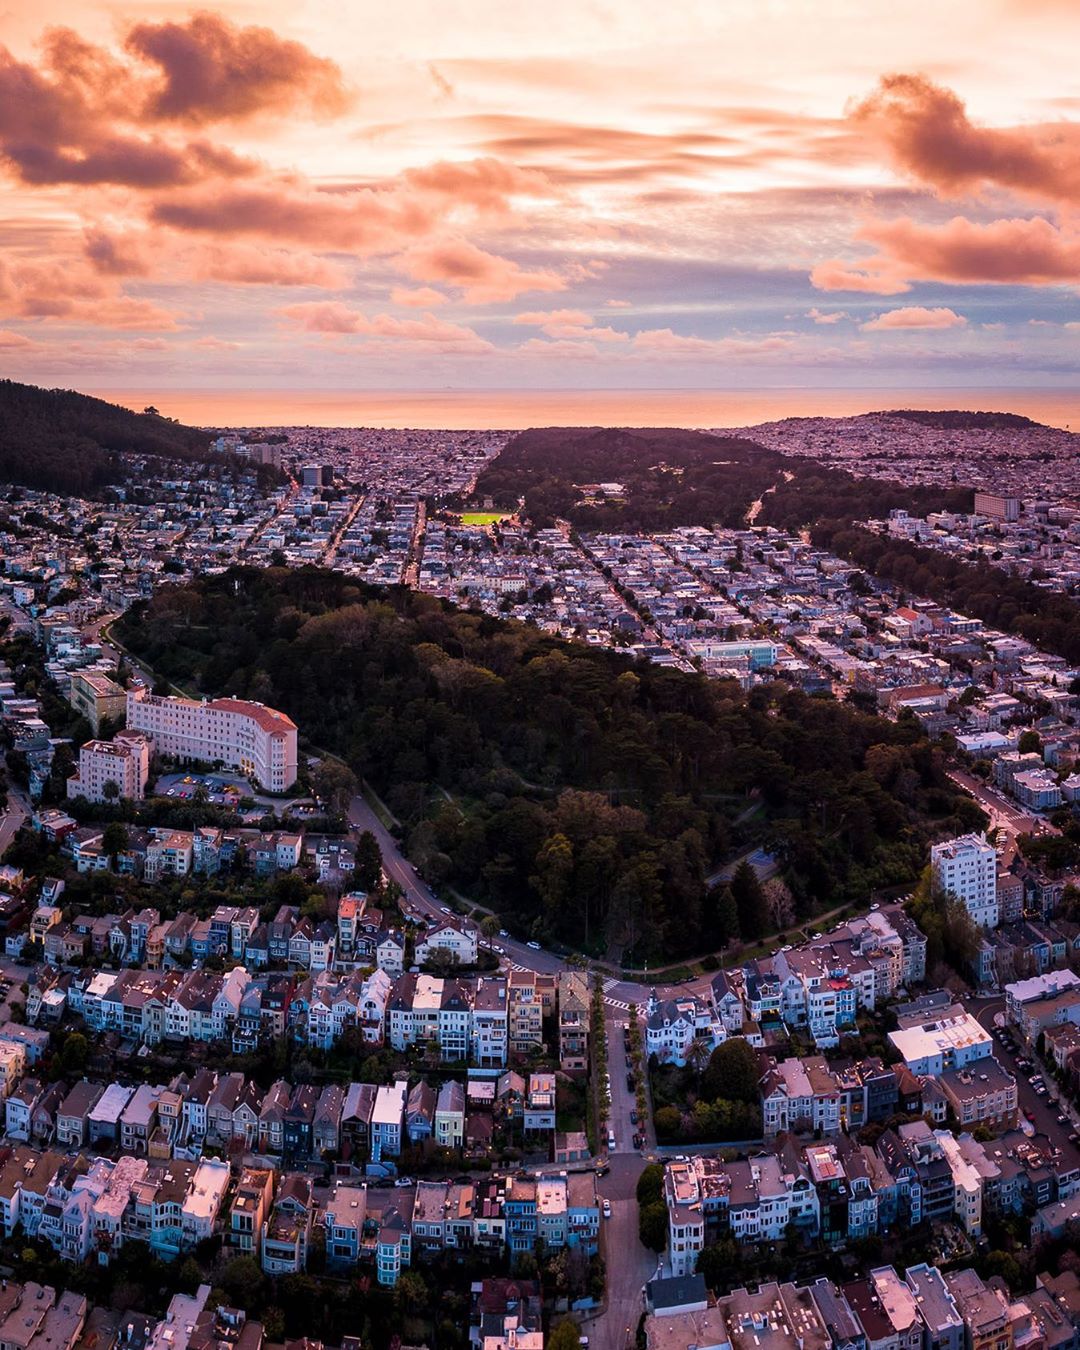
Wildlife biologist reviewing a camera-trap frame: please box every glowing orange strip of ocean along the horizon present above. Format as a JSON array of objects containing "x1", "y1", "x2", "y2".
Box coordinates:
[{"x1": 86, "y1": 387, "x2": 1080, "y2": 431}]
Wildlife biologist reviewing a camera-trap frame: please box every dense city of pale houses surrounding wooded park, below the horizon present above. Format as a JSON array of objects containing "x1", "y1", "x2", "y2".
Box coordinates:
[{"x1": 0, "y1": 396, "x2": 1080, "y2": 1350}]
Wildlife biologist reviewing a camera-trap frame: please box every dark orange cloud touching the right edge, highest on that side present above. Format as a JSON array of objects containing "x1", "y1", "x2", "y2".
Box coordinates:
[{"x1": 852, "y1": 74, "x2": 1080, "y2": 203}]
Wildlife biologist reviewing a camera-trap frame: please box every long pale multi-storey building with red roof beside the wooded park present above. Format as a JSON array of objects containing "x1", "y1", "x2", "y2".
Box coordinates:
[{"x1": 127, "y1": 689, "x2": 297, "y2": 792}]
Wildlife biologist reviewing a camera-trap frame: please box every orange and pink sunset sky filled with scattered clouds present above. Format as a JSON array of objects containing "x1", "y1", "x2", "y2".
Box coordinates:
[{"x1": 0, "y1": 0, "x2": 1080, "y2": 390}]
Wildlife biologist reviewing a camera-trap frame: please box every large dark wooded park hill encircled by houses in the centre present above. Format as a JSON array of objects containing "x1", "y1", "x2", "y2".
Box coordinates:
[{"x1": 117, "y1": 568, "x2": 981, "y2": 957}]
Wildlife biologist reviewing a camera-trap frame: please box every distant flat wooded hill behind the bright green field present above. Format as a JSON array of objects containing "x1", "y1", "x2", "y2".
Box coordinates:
[{"x1": 477, "y1": 414, "x2": 972, "y2": 531}]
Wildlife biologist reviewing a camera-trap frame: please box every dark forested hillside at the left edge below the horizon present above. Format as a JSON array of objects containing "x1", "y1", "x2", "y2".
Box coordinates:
[{"x1": 0, "y1": 379, "x2": 211, "y2": 494}]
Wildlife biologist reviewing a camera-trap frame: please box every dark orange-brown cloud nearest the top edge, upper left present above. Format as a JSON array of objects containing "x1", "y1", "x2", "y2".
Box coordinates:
[{"x1": 126, "y1": 11, "x2": 348, "y2": 124}]
